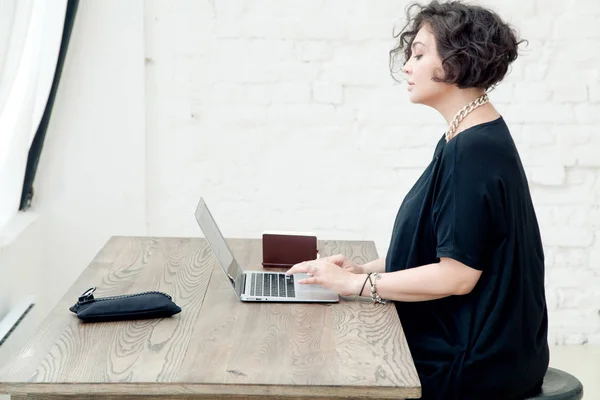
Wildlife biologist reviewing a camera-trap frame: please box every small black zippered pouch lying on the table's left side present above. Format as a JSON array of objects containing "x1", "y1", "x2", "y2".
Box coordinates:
[{"x1": 69, "y1": 287, "x2": 181, "y2": 322}]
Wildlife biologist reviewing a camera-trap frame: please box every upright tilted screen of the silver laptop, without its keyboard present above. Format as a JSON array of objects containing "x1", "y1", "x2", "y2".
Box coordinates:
[{"x1": 194, "y1": 198, "x2": 243, "y2": 297}]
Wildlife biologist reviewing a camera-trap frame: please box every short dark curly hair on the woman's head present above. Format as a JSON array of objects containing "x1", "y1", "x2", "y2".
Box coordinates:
[{"x1": 390, "y1": 0, "x2": 526, "y2": 91}]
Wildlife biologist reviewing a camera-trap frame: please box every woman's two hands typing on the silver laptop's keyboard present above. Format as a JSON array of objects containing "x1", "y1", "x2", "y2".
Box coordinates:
[{"x1": 286, "y1": 257, "x2": 363, "y2": 296}]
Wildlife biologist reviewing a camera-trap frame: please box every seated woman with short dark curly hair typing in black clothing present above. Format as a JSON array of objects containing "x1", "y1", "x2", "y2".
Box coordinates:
[{"x1": 288, "y1": 1, "x2": 549, "y2": 400}]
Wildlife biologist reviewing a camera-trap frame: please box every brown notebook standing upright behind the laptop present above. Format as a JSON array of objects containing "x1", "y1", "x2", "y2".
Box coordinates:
[{"x1": 262, "y1": 232, "x2": 318, "y2": 268}]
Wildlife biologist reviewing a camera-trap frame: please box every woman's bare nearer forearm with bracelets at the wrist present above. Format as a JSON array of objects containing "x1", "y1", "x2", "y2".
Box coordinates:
[{"x1": 354, "y1": 257, "x2": 481, "y2": 302}]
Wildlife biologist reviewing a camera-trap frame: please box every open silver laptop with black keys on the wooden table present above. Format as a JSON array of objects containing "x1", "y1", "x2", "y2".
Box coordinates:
[{"x1": 194, "y1": 198, "x2": 340, "y2": 303}]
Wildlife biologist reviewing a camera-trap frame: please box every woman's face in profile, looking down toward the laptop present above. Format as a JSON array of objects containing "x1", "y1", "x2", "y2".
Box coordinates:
[{"x1": 403, "y1": 25, "x2": 450, "y2": 106}]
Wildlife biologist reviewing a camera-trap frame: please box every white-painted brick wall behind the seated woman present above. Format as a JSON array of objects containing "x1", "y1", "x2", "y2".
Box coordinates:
[{"x1": 145, "y1": 0, "x2": 600, "y2": 344}]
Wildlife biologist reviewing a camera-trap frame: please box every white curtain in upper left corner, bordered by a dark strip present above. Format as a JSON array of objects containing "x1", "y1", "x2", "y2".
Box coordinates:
[{"x1": 0, "y1": 0, "x2": 67, "y2": 233}]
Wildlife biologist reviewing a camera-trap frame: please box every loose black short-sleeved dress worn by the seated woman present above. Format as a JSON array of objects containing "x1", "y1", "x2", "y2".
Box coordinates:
[{"x1": 386, "y1": 117, "x2": 549, "y2": 400}]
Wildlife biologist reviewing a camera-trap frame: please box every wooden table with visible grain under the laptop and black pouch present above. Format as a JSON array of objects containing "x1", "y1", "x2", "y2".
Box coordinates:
[{"x1": 0, "y1": 237, "x2": 421, "y2": 399}]
